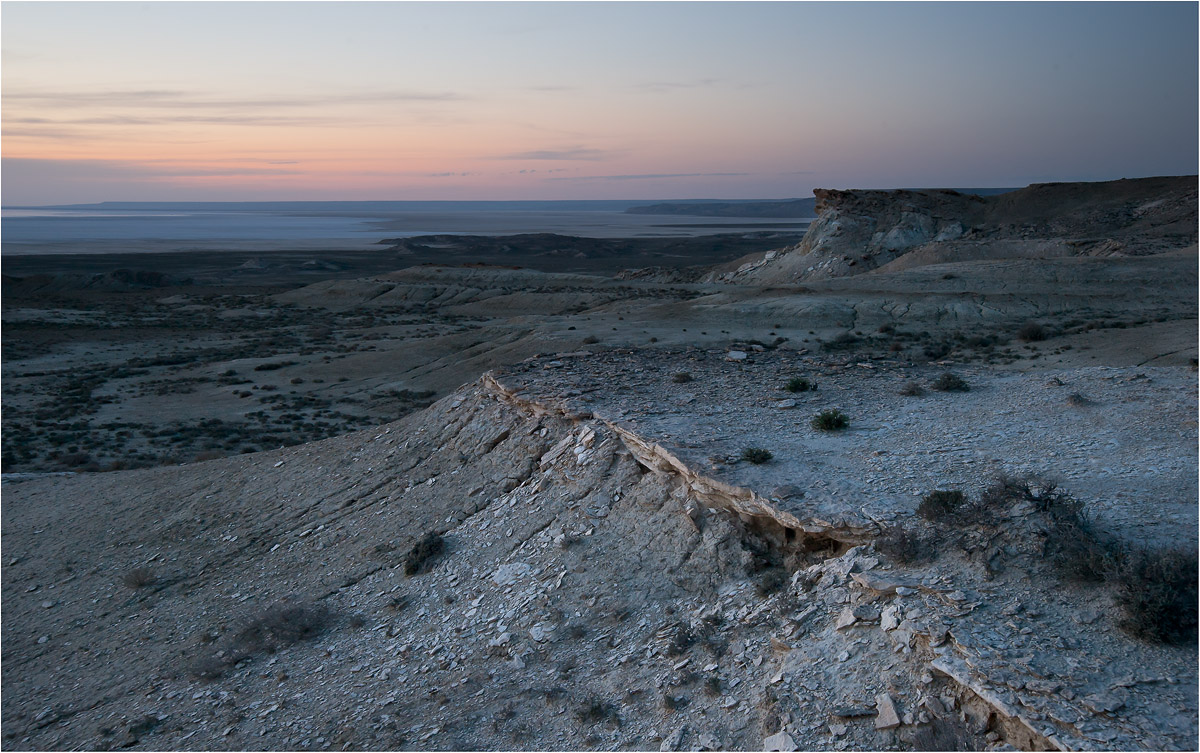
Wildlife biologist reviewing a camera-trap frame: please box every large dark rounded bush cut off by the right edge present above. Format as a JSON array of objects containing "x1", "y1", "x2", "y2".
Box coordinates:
[{"x1": 1112, "y1": 549, "x2": 1200, "y2": 644}]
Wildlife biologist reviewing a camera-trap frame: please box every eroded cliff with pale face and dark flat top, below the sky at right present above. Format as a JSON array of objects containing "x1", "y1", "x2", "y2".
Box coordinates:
[{"x1": 709, "y1": 176, "x2": 1196, "y2": 284}]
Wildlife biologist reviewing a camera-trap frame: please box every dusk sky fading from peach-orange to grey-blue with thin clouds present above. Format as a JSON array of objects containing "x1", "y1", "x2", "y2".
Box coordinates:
[{"x1": 0, "y1": 1, "x2": 1200, "y2": 206}]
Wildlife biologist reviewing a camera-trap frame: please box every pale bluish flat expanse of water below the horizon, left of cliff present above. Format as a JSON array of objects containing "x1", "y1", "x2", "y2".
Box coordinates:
[{"x1": 0, "y1": 199, "x2": 806, "y2": 255}]
